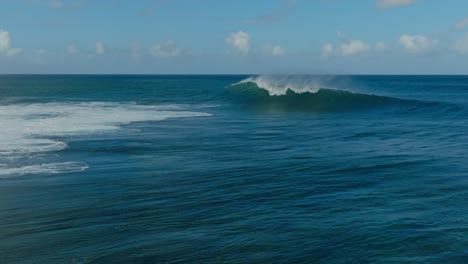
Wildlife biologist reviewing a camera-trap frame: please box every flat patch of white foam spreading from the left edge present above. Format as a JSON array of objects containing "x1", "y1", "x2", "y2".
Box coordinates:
[{"x1": 0, "y1": 102, "x2": 209, "y2": 175}]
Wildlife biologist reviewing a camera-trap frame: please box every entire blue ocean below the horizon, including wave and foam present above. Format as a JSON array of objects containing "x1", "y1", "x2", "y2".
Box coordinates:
[{"x1": 0, "y1": 75, "x2": 468, "y2": 263}]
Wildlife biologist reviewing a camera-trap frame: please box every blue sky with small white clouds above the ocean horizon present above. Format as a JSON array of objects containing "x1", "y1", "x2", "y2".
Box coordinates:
[{"x1": 0, "y1": 0, "x2": 468, "y2": 74}]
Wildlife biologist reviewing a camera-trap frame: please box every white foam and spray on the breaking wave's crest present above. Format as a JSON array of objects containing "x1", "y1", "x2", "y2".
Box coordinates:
[{"x1": 237, "y1": 75, "x2": 334, "y2": 96}]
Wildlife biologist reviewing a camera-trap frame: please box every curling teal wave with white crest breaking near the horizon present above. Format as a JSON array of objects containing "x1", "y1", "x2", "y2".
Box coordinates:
[{"x1": 228, "y1": 76, "x2": 440, "y2": 112}]
